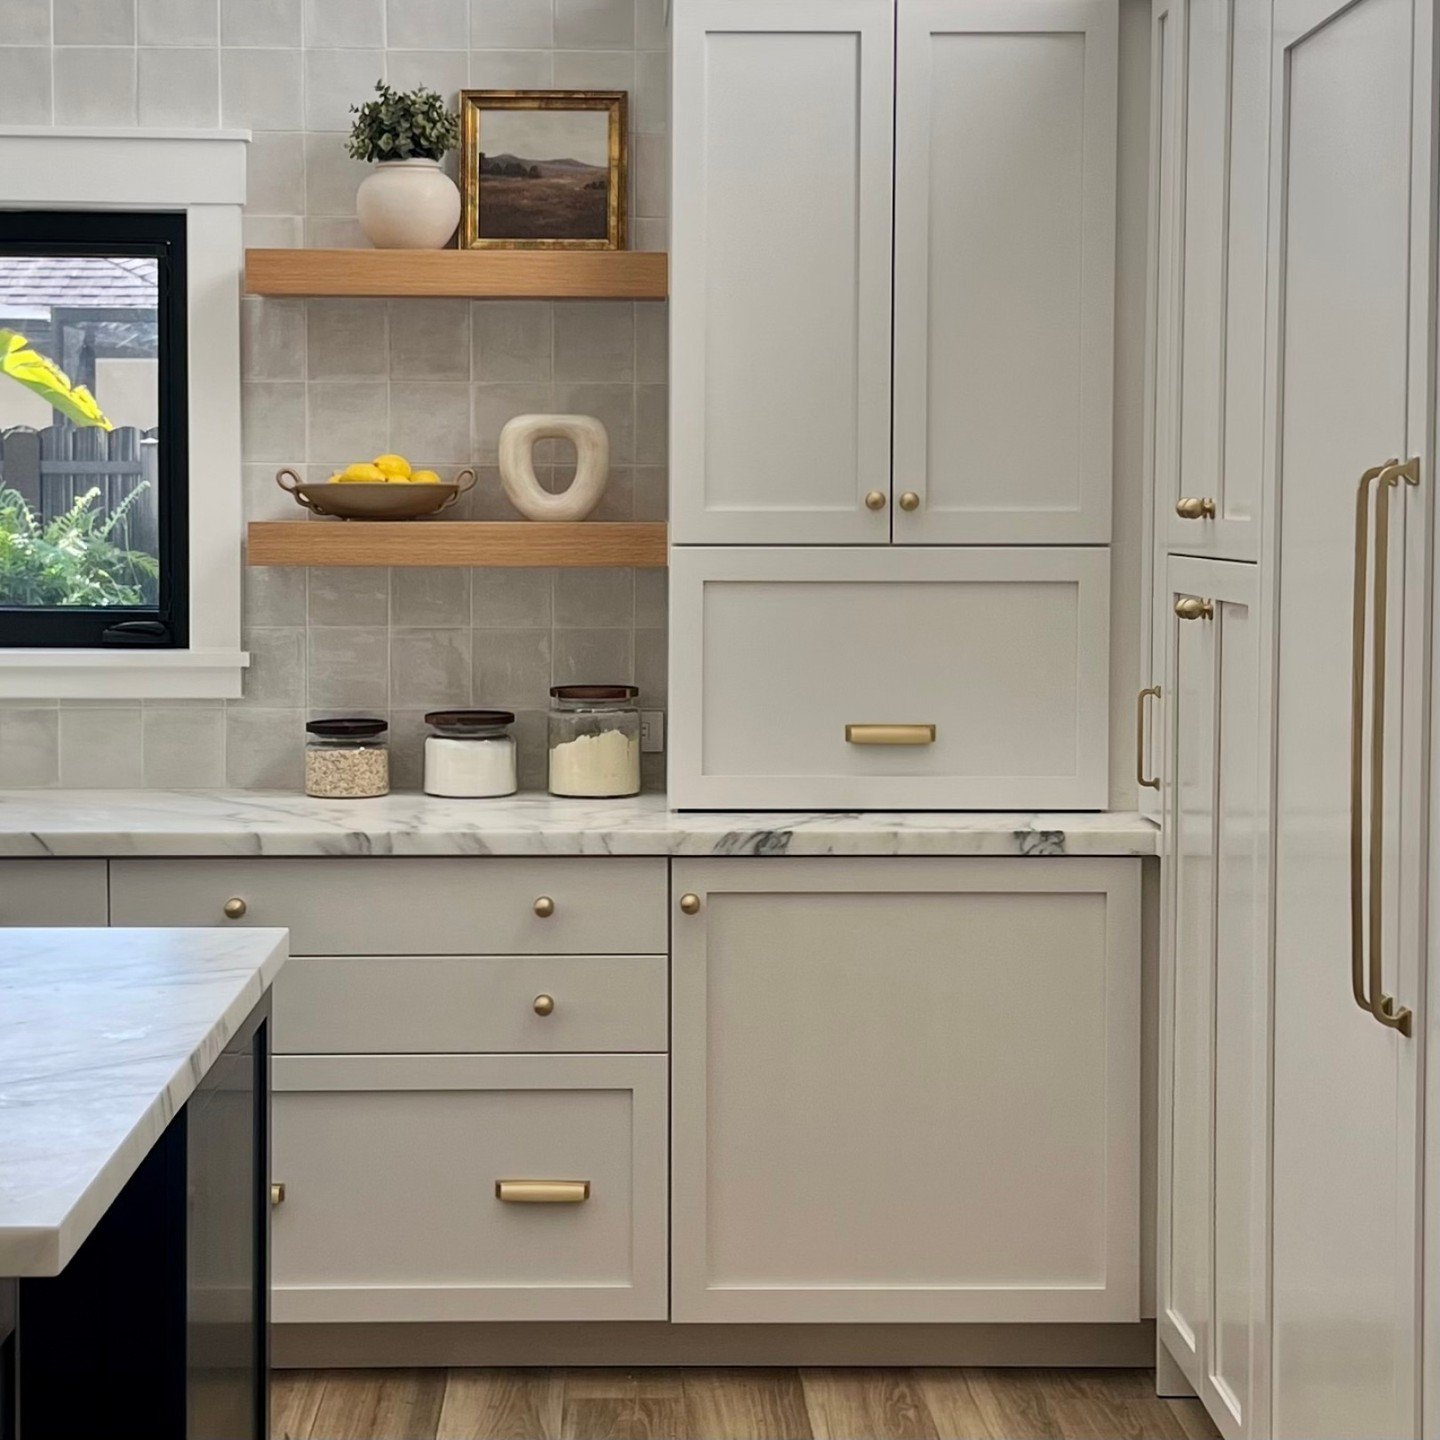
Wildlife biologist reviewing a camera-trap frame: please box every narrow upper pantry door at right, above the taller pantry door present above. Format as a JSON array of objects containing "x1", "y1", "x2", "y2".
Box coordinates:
[{"x1": 1156, "y1": 0, "x2": 1272, "y2": 560}]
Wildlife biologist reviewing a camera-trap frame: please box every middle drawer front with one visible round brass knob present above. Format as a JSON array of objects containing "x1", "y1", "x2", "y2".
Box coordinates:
[{"x1": 275, "y1": 955, "x2": 670, "y2": 1054}]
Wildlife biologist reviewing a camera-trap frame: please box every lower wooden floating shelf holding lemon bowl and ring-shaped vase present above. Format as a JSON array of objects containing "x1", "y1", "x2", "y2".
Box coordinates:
[{"x1": 246, "y1": 520, "x2": 667, "y2": 569}]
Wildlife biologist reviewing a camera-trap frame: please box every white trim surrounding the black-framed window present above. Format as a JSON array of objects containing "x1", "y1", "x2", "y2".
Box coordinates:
[{"x1": 0, "y1": 125, "x2": 251, "y2": 700}]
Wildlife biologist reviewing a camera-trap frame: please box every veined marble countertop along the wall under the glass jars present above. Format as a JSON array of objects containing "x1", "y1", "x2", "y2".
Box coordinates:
[{"x1": 0, "y1": 791, "x2": 1158, "y2": 857}]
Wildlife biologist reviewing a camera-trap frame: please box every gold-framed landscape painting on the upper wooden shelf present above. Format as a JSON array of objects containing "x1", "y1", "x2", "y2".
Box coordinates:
[{"x1": 459, "y1": 89, "x2": 629, "y2": 251}]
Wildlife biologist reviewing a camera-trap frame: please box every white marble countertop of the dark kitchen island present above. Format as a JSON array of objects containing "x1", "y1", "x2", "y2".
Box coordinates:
[{"x1": 0, "y1": 929, "x2": 288, "y2": 1277}]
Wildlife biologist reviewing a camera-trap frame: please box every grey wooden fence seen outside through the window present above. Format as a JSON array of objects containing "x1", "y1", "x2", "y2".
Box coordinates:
[{"x1": 0, "y1": 425, "x2": 160, "y2": 554}]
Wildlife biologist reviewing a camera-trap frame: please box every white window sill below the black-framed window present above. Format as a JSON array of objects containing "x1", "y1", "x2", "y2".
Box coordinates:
[{"x1": 0, "y1": 649, "x2": 251, "y2": 700}]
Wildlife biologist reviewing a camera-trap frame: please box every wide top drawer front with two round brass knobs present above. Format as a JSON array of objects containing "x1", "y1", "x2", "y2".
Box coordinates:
[{"x1": 111, "y1": 857, "x2": 667, "y2": 955}]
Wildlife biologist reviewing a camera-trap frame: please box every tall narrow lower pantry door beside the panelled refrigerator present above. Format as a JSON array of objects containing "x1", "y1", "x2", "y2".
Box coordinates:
[{"x1": 1158, "y1": 557, "x2": 1269, "y2": 1440}]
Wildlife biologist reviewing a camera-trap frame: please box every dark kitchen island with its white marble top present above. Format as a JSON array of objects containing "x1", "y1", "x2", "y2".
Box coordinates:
[{"x1": 0, "y1": 929, "x2": 288, "y2": 1440}]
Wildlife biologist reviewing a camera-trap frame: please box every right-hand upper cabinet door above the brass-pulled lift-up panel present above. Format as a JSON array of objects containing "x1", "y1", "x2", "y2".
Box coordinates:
[{"x1": 894, "y1": 0, "x2": 1117, "y2": 544}]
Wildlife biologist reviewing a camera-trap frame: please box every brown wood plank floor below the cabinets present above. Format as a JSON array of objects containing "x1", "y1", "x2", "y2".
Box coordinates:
[{"x1": 274, "y1": 1369, "x2": 1218, "y2": 1440}]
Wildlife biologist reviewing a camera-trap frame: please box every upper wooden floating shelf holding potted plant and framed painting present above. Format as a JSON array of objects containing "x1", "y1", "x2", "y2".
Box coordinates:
[{"x1": 245, "y1": 249, "x2": 670, "y2": 300}]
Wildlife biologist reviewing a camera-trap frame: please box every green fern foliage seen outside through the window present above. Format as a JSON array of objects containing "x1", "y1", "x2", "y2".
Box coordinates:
[{"x1": 0, "y1": 484, "x2": 160, "y2": 608}]
